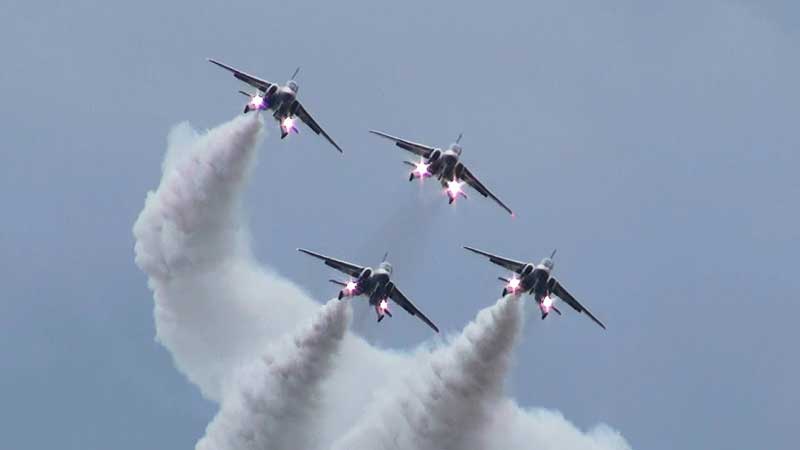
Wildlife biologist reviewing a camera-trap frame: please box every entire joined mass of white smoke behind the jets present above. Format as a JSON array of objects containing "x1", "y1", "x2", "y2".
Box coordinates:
[{"x1": 133, "y1": 114, "x2": 630, "y2": 450}]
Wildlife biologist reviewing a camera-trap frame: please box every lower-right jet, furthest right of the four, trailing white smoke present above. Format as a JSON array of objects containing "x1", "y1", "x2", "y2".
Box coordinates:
[{"x1": 464, "y1": 247, "x2": 606, "y2": 330}]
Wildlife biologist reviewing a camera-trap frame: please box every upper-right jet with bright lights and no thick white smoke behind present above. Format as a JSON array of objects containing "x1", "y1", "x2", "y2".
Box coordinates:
[{"x1": 370, "y1": 130, "x2": 514, "y2": 216}]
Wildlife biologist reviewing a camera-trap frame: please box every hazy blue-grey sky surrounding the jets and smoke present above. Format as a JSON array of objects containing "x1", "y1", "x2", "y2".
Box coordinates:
[{"x1": 0, "y1": 0, "x2": 800, "y2": 449}]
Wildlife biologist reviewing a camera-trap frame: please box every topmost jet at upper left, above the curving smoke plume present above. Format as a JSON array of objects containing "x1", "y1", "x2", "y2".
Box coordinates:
[{"x1": 208, "y1": 58, "x2": 343, "y2": 153}]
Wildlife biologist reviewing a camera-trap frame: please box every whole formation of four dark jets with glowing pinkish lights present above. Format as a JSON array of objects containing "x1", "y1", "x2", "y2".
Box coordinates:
[{"x1": 208, "y1": 59, "x2": 606, "y2": 333}]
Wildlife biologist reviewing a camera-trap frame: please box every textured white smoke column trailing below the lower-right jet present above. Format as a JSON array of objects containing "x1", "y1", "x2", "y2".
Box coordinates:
[{"x1": 333, "y1": 295, "x2": 522, "y2": 450}]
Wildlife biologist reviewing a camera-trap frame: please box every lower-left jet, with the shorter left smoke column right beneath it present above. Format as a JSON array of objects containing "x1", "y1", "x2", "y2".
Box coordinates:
[{"x1": 297, "y1": 248, "x2": 439, "y2": 333}]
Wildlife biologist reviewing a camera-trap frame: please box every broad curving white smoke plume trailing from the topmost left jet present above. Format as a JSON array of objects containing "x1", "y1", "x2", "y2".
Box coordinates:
[{"x1": 133, "y1": 114, "x2": 315, "y2": 400}]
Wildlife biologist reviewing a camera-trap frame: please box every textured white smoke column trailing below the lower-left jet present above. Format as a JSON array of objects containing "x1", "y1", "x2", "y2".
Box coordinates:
[{"x1": 196, "y1": 299, "x2": 350, "y2": 450}]
